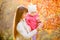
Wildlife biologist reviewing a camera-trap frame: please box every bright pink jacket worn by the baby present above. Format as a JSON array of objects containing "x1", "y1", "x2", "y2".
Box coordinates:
[{"x1": 26, "y1": 13, "x2": 38, "y2": 30}]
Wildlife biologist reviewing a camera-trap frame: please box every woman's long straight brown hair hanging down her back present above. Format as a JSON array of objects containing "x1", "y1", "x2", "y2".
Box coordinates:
[{"x1": 14, "y1": 6, "x2": 28, "y2": 40}]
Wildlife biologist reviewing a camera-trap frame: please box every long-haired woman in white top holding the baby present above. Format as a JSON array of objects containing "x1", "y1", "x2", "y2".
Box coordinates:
[{"x1": 14, "y1": 7, "x2": 38, "y2": 40}]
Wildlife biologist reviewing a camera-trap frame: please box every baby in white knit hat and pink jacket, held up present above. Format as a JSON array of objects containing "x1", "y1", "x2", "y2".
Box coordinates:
[{"x1": 26, "y1": 4, "x2": 40, "y2": 30}]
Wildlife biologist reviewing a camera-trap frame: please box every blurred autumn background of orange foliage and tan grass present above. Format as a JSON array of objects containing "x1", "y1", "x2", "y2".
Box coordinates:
[{"x1": 0, "y1": 0, "x2": 60, "y2": 40}]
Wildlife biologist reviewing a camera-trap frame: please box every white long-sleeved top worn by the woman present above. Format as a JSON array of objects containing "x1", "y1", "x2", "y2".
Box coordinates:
[{"x1": 17, "y1": 20, "x2": 37, "y2": 38}]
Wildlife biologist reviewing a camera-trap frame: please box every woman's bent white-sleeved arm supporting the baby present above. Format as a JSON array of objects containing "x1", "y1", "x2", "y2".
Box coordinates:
[{"x1": 17, "y1": 24, "x2": 37, "y2": 38}]
